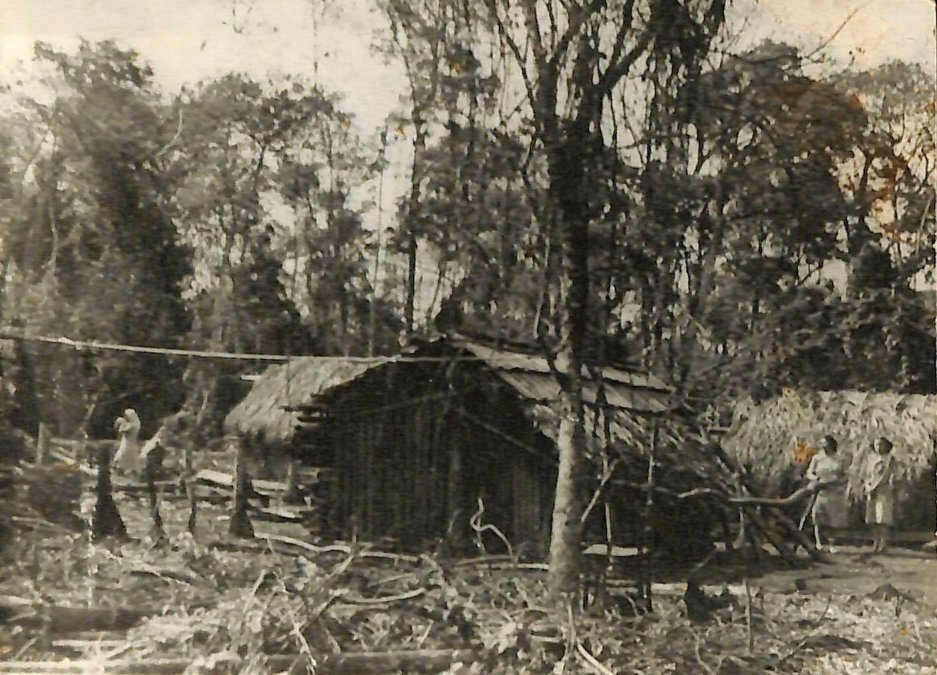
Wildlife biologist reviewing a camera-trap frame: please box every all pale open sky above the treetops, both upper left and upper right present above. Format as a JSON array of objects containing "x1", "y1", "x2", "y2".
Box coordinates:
[{"x1": 0, "y1": 0, "x2": 937, "y2": 136}]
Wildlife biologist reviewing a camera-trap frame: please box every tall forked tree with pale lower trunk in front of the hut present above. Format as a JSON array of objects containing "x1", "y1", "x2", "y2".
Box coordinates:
[{"x1": 476, "y1": 0, "x2": 725, "y2": 592}]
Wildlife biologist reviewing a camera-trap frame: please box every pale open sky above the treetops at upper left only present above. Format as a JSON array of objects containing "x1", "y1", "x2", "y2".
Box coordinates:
[{"x1": 0, "y1": 0, "x2": 405, "y2": 131}]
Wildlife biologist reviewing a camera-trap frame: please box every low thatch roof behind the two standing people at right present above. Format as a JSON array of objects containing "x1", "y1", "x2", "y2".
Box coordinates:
[{"x1": 724, "y1": 391, "x2": 937, "y2": 499}]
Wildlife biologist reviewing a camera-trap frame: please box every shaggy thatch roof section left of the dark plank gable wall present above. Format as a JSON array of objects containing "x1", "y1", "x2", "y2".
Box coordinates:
[{"x1": 224, "y1": 357, "x2": 375, "y2": 446}]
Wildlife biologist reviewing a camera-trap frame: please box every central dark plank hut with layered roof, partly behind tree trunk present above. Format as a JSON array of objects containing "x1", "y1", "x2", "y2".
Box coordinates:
[{"x1": 308, "y1": 335, "x2": 744, "y2": 557}]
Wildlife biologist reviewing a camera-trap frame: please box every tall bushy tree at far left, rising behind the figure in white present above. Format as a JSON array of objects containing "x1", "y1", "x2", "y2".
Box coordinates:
[{"x1": 5, "y1": 42, "x2": 189, "y2": 433}]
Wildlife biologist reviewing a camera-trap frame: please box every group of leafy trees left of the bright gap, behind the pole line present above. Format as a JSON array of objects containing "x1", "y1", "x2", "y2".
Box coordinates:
[{"x1": 2, "y1": 42, "x2": 396, "y2": 435}]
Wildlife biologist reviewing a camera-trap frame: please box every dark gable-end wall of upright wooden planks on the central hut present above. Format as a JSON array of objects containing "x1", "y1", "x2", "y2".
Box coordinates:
[{"x1": 327, "y1": 374, "x2": 555, "y2": 555}]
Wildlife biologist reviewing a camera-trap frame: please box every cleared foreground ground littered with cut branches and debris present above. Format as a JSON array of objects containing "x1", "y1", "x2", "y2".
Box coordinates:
[{"x1": 0, "y1": 476, "x2": 937, "y2": 675}]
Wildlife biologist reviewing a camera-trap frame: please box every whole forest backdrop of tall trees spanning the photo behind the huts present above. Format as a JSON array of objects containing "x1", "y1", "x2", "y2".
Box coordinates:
[{"x1": 0, "y1": 10, "x2": 935, "y2": 444}]
